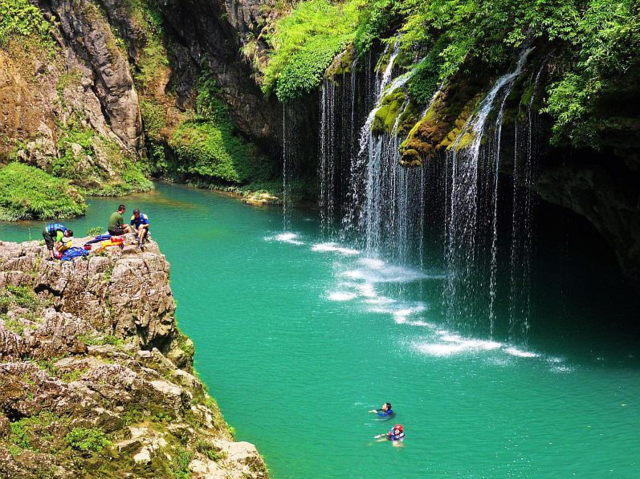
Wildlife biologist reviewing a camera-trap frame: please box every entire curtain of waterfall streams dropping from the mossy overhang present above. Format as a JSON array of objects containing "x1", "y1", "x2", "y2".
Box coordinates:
[{"x1": 310, "y1": 41, "x2": 539, "y2": 342}]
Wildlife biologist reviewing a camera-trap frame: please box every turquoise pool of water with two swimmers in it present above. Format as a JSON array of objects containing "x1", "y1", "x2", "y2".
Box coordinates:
[{"x1": 0, "y1": 184, "x2": 640, "y2": 479}]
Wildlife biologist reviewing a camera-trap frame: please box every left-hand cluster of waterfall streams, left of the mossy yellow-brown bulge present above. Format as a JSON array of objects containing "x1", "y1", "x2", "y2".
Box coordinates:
[{"x1": 318, "y1": 38, "x2": 435, "y2": 263}]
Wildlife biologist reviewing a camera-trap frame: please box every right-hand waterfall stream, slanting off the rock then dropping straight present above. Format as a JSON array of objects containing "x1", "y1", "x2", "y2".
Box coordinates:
[{"x1": 444, "y1": 49, "x2": 531, "y2": 333}]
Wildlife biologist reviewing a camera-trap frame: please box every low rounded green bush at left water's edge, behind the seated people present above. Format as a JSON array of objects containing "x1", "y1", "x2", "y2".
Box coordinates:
[{"x1": 0, "y1": 163, "x2": 87, "y2": 221}]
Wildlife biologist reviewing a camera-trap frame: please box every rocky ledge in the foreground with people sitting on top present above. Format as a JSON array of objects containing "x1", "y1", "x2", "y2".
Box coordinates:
[{"x1": 0, "y1": 239, "x2": 268, "y2": 478}]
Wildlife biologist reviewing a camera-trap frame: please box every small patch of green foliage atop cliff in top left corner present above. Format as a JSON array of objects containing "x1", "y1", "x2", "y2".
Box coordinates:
[{"x1": 0, "y1": 0, "x2": 55, "y2": 48}]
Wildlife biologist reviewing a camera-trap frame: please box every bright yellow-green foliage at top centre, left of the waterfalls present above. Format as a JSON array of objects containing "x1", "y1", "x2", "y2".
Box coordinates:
[{"x1": 263, "y1": 0, "x2": 364, "y2": 101}]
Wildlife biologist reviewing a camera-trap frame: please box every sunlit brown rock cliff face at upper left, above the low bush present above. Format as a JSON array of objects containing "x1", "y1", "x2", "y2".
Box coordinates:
[{"x1": 0, "y1": 1, "x2": 150, "y2": 194}]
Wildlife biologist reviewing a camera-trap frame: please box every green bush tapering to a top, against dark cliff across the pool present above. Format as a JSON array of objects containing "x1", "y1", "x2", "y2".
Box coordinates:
[{"x1": 171, "y1": 72, "x2": 255, "y2": 183}]
